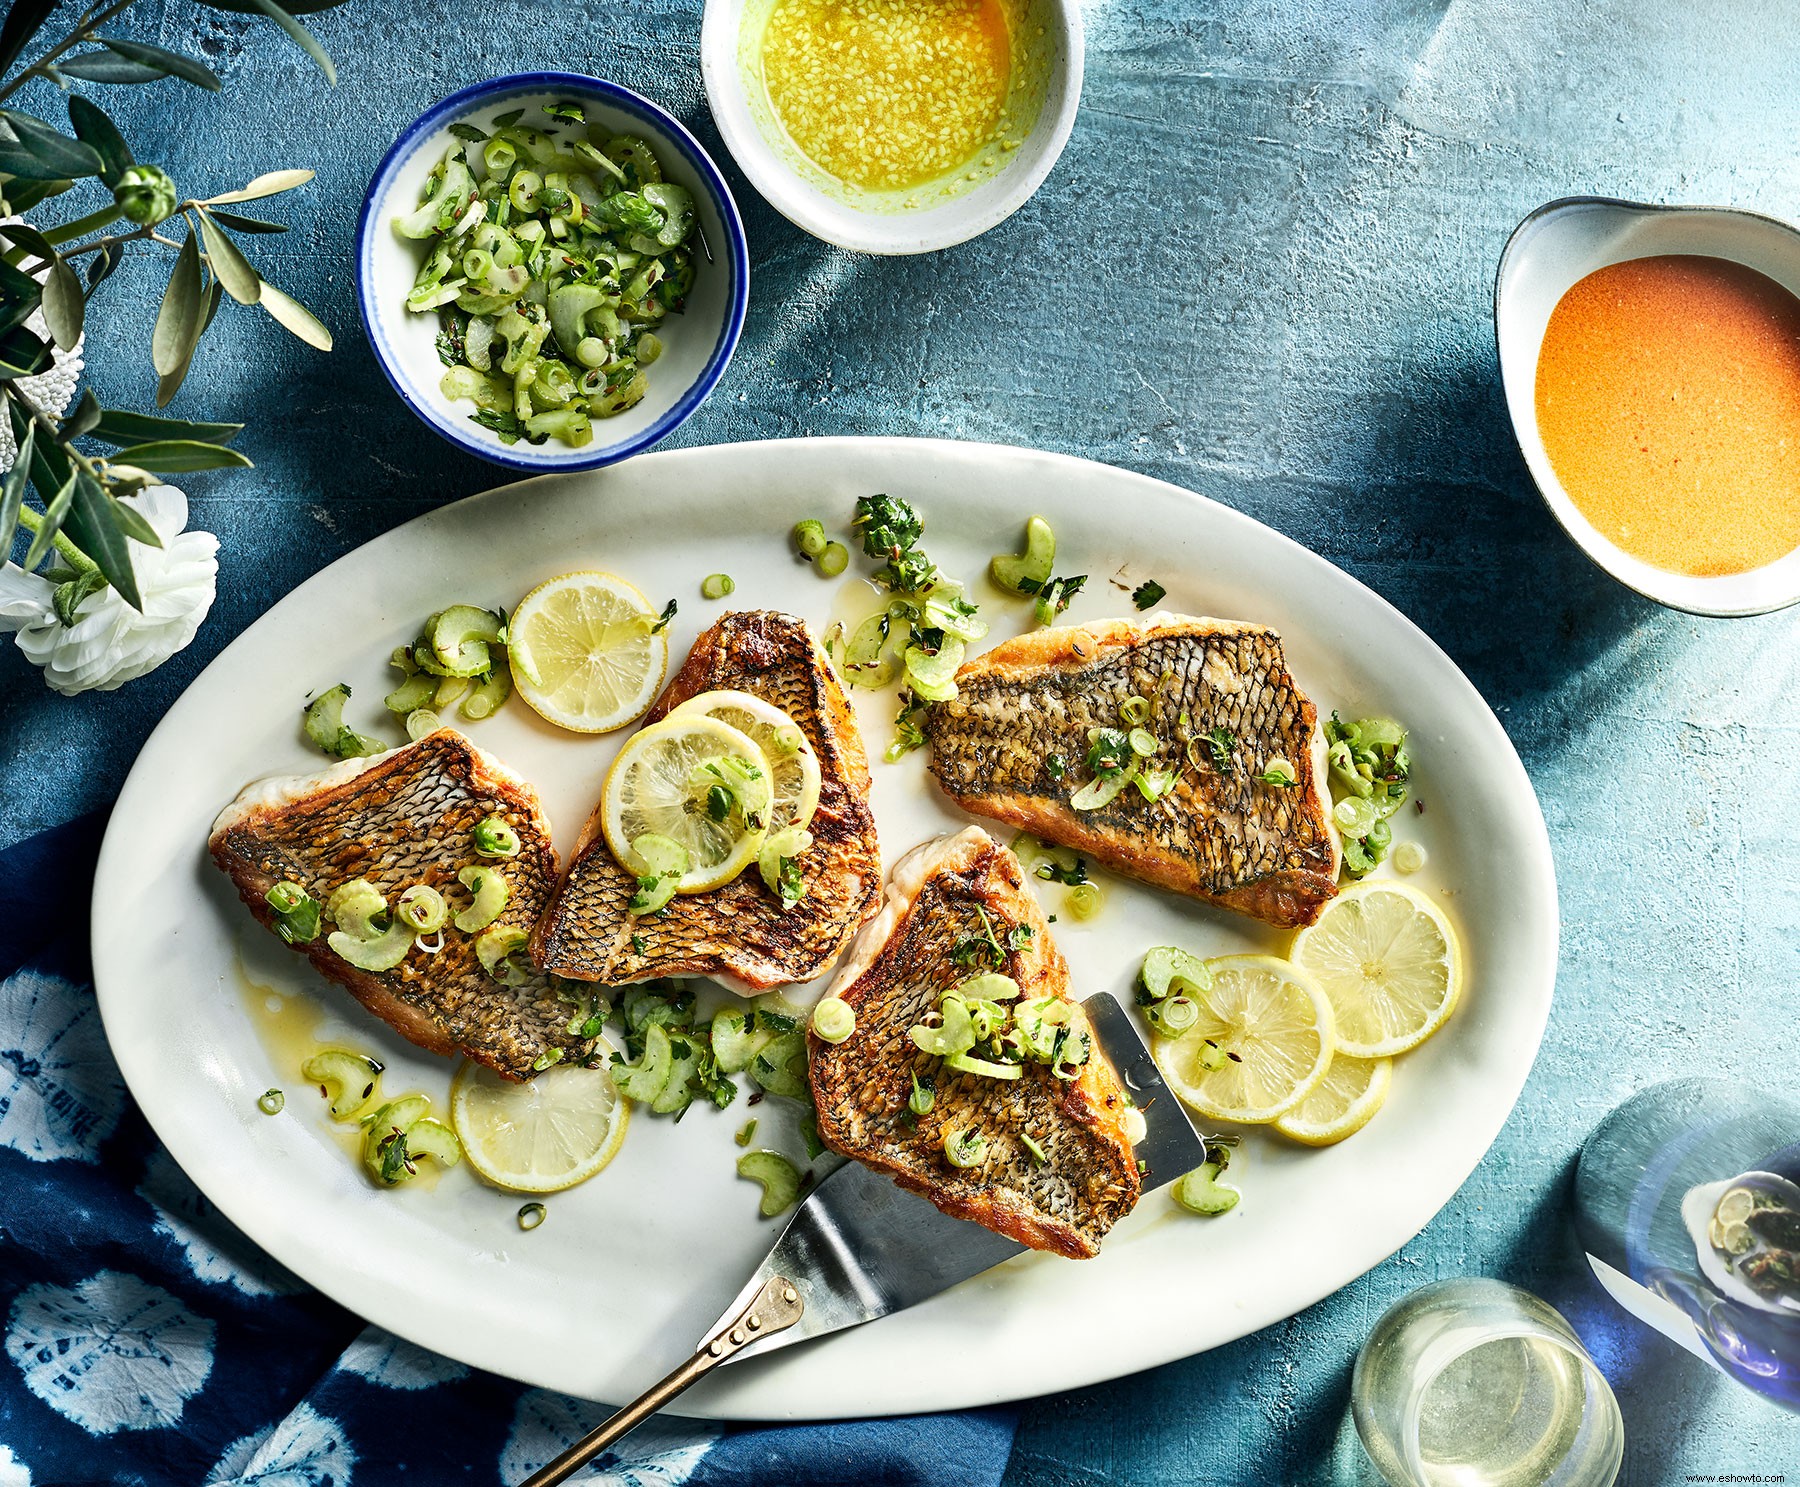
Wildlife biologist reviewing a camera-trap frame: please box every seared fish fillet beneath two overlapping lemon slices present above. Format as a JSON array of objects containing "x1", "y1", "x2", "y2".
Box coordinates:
[{"x1": 531, "y1": 610, "x2": 882, "y2": 992}]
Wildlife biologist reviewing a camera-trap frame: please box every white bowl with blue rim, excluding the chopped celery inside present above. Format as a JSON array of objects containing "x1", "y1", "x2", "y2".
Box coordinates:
[{"x1": 356, "y1": 72, "x2": 751, "y2": 475}]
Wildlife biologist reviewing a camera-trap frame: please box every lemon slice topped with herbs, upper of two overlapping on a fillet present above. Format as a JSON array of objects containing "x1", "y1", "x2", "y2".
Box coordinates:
[{"x1": 599, "y1": 713, "x2": 772, "y2": 893}]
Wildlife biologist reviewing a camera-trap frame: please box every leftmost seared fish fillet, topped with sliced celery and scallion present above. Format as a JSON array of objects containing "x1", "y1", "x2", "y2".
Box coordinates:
[{"x1": 211, "y1": 729, "x2": 592, "y2": 1080}]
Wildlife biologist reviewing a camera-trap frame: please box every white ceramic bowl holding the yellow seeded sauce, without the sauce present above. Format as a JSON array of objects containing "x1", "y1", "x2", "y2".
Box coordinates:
[{"x1": 700, "y1": 0, "x2": 1082, "y2": 254}]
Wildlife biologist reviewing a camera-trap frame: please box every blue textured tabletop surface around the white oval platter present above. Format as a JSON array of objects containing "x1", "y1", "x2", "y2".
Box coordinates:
[{"x1": 0, "y1": 0, "x2": 1800, "y2": 1487}]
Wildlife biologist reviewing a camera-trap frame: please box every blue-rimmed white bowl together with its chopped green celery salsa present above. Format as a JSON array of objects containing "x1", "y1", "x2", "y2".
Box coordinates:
[{"x1": 356, "y1": 72, "x2": 749, "y2": 472}]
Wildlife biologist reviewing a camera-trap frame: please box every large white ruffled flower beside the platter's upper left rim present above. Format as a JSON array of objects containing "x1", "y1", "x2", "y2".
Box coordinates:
[{"x1": 0, "y1": 486, "x2": 220, "y2": 697}]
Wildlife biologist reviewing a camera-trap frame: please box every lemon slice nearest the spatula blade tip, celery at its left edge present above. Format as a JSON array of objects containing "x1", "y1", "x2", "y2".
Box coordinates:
[{"x1": 1152, "y1": 956, "x2": 1336, "y2": 1125}]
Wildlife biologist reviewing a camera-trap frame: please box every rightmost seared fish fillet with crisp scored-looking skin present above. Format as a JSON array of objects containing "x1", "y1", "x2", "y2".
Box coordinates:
[{"x1": 925, "y1": 616, "x2": 1339, "y2": 925}]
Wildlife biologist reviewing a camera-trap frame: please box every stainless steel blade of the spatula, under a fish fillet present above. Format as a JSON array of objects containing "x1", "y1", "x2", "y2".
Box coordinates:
[{"x1": 707, "y1": 992, "x2": 1206, "y2": 1363}]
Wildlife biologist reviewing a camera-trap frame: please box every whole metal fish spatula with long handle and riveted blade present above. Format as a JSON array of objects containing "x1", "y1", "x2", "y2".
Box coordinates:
[{"x1": 522, "y1": 992, "x2": 1206, "y2": 1487}]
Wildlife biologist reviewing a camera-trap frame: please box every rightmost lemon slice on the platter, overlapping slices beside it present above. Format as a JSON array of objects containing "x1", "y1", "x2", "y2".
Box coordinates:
[{"x1": 1289, "y1": 880, "x2": 1463, "y2": 1059}]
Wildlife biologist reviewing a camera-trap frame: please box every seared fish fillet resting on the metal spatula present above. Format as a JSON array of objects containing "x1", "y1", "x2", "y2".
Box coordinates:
[{"x1": 810, "y1": 826, "x2": 1141, "y2": 1260}]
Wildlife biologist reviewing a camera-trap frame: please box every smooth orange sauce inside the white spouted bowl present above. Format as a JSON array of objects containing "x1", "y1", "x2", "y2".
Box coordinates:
[{"x1": 1537, "y1": 254, "x2": 1800, "y2": 576}]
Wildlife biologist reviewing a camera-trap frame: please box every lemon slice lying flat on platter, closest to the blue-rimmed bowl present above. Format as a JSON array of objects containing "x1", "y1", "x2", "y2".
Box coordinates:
[{"x1": 506, "y1": 572, "x2": 670, "y2": 733}]
